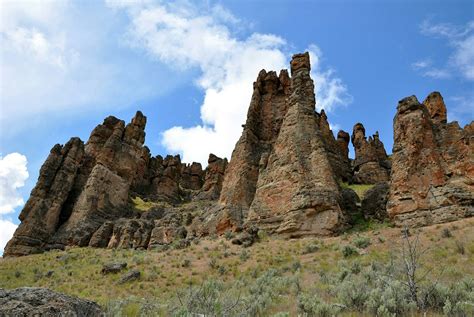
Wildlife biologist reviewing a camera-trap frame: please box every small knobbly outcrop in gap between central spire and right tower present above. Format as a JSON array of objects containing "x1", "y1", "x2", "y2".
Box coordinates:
[{"x1": 351, "y1": 123, "x2": 391, "y2": 184}]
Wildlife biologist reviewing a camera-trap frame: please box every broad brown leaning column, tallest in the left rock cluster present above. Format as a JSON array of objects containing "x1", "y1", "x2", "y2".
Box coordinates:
[{"x1": 52, "y1": 111, "x2": 149, "y2": 246}]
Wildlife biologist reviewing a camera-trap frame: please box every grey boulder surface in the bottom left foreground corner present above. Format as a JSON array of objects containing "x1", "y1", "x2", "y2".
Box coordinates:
[{"x1": 0, "y1": 287, "x2": 103, "y2": 317}]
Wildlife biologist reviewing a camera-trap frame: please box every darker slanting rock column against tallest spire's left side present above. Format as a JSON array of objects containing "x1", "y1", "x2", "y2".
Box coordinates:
[{"x1": 213, "y1": 70, "x2": 290, "y2": 232}]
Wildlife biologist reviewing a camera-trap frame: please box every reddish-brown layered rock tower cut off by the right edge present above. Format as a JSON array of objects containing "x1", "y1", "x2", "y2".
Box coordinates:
[{"x1": 387, "y1": 92, "x2": 474, "y2": 226}]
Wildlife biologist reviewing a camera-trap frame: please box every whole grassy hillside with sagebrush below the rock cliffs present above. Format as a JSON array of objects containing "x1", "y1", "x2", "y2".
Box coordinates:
[{"x1": 0, "y1": 218, "x2": 474, "y2": 316}]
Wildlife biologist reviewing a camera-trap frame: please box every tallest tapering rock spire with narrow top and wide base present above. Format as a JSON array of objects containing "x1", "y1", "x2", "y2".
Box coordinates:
[{"x1": 248, "y1": 53, "x2": 342, "y2": 237}]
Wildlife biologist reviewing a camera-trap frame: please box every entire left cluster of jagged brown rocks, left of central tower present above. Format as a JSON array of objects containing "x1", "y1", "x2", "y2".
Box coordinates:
[{"x1": 5, "y1": 112, "x2": 227, "y2": 256}]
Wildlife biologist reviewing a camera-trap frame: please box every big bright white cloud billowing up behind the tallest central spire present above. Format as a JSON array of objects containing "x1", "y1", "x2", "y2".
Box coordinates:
[{"x1": 115, "y1": 1, "x2": 351, "y2": 165}]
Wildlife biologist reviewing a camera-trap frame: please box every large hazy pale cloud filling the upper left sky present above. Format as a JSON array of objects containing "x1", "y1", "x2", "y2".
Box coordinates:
[{"x1": 0, "y1": 0, "x2": 180, "y2": 138}]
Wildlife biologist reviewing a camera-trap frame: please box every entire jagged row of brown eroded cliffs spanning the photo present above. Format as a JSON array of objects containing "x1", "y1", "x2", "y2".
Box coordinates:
[{"x1": 4, "y1": 53, "x2": 474, "y2": 256}]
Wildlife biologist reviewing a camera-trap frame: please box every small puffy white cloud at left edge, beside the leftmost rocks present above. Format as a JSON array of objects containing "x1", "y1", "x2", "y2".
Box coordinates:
[{"x1": 0, "y1": 153, "x2": 29, "y2": 214}]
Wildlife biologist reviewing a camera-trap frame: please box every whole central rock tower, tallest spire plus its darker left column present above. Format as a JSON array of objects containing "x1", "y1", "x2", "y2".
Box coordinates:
[{"x1": 220, "y1": 53, "x2": 343, "y2": 236}]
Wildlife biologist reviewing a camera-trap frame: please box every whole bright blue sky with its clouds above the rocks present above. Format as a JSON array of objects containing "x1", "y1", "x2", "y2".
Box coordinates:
[{"x1": 0, "y1": 0, "x2": 474, "y2": 252}]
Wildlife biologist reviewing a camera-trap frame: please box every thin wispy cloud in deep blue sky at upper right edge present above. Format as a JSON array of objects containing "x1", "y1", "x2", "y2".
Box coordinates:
[{"x1": 412, "y1": 20, "x2": 474, "y2": 80}]
